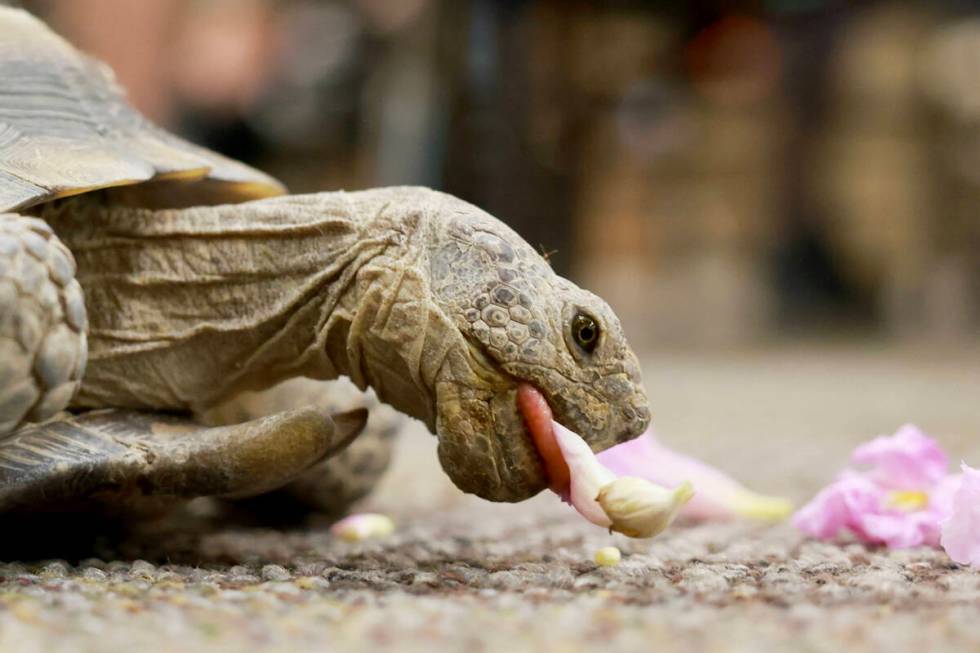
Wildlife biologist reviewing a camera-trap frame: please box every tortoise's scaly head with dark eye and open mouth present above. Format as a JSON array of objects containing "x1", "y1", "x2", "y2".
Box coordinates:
[{"x1": 428, "y1": 191, "x2": 650, "y2": 501}]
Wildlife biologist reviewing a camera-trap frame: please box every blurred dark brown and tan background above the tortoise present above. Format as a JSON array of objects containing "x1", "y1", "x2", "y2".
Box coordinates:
[{"x1": 22, "y1": 0, "x2": 980, "y2": 349}]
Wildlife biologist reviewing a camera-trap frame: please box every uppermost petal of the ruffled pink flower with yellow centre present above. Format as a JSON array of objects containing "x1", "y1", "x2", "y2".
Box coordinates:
[{"x1": 851, "y1": 424, "x2": 949, "y2": 489}]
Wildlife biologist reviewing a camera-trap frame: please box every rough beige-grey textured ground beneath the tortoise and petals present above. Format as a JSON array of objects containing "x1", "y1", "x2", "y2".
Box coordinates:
[{"x1": 0, "y1": 347, "x2": 980, "y2": 652}]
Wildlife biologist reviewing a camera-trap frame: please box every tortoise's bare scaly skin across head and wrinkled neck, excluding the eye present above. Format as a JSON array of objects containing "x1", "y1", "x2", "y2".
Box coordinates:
[{"x1": 42, "y1": 188, "x2": 649, "y2": 501}]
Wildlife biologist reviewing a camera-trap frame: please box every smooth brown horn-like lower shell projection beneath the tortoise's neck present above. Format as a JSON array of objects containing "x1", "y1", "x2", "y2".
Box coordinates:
[{"x1": 0, "y1": 409, "x2": 367, "y2": 513}]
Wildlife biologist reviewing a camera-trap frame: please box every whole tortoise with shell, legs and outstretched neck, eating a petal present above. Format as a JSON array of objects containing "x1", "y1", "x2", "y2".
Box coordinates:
[{"x1": 0, "y1": 8, "x2": 650, "y2": 513}]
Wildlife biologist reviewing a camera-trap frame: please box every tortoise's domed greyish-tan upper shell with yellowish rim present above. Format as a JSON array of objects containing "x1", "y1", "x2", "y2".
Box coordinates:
[{"x1": 0, "y1": 7, "x2": 286, "y2": 212}]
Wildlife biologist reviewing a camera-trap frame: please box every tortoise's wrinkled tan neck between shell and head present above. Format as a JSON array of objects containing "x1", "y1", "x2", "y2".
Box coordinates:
[{"x1": 44, "y1": 191, "x2": 448, "y2": 418}]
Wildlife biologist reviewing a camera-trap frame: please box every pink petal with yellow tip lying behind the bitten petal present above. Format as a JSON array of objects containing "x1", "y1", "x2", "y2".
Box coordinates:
[{"x1": 598, "y1": 430, "x2": 792, "y2": 519}]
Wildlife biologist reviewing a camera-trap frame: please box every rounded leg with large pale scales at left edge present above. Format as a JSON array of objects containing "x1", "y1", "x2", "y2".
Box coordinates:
[{"x1": 0, "y1": 214, "x2": 86, "y2": 435}]
